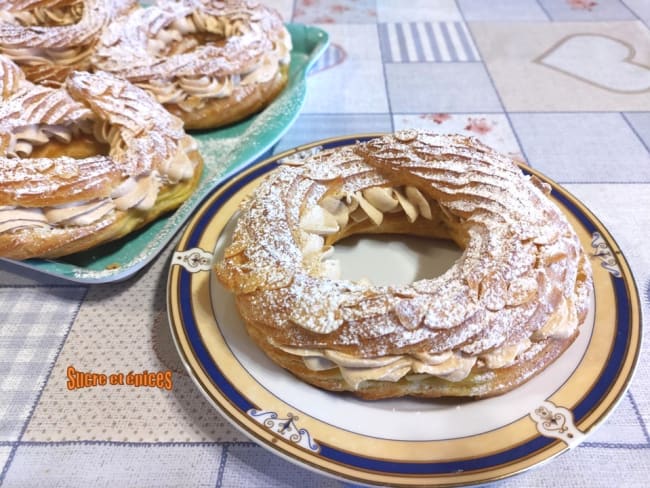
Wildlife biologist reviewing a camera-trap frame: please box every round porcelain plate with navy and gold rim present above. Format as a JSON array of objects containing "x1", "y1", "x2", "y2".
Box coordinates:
[{"x1": 168, "y1": 136, "x2": 641, "y2": 486}]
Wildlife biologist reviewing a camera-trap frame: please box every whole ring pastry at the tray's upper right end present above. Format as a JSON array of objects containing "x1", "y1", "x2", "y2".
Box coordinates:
[{"x1": 92, "y1": 0, "x2": 292, "y2": 129}]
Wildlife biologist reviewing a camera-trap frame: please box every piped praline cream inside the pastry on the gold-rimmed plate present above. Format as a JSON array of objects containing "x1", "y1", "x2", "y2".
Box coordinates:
[{"x1": 280, "y1": 186, "x2": 578, "y2": 390}]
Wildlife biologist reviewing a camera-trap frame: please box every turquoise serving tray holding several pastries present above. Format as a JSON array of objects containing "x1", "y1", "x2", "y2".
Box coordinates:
[{"x1": 0, "y1": 24, "x2": 329, "y2": 283}]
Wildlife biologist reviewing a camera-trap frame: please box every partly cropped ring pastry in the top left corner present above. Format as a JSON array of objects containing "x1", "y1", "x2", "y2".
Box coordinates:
[{"x1": 0, "y1": 0, "x2": 138, "y2": 86}]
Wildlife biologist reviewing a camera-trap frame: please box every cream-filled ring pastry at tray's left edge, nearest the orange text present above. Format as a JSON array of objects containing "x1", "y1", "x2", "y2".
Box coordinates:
[{"x1": 0, "y1": 56, "x2": 202, "y2": 259}]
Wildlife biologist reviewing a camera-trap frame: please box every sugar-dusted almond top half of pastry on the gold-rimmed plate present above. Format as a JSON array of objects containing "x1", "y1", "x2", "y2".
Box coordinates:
[{"x1": 216, "y1": 131, "x2": 590, "y2": 386}]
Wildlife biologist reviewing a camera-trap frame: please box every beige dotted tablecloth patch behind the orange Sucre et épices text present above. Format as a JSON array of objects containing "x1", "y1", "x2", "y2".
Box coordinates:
[{"x1": 24, "y1": 242, "x2": 245, "y2": 442}]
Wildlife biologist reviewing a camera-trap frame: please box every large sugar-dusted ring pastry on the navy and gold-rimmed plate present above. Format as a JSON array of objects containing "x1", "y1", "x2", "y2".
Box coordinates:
[{"x1": 216, "y1": 130, "x2": 591, "y2": 399}]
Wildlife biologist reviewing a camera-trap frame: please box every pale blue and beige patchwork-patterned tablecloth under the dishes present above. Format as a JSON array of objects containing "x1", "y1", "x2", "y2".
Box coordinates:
[{"x1": 0, "y1": 0, "x2": 650, "y2": 488}]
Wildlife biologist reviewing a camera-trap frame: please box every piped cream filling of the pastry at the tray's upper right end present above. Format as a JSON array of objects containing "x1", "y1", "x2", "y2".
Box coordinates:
[{"x1": 138, "y1": 11, "x2": 292, "y2": 111}]
